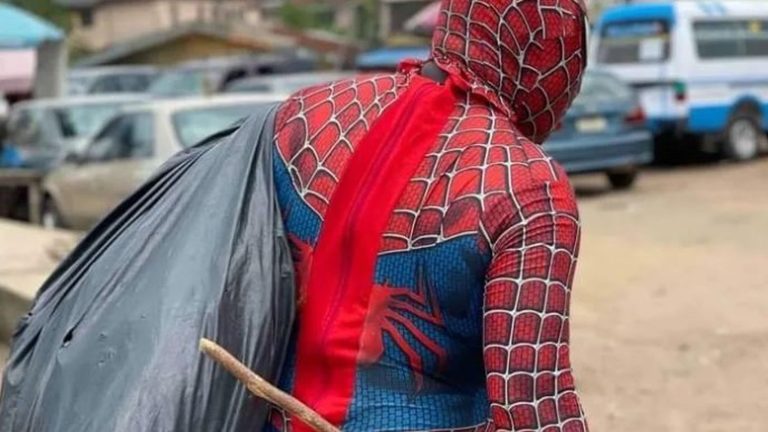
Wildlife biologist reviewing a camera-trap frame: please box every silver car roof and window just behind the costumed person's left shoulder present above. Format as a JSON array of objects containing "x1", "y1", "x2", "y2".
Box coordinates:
[{"x1": 224, "y1": 72, "x2": 352, "y2": 94}]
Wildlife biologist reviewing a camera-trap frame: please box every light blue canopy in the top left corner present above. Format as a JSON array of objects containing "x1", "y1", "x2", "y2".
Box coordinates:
[{"x1": 0, "y1": 3, "x2": 64, "y2": 48}]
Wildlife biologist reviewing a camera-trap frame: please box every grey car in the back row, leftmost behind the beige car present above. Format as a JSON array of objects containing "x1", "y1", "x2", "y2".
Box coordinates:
[{"x1": 67, "y1": 66, "x2": 158, "y2": 95}]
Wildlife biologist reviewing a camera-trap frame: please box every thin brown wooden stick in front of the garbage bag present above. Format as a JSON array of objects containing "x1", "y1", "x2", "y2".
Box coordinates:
[{"x1": 200, "y1": 339, "x2": 340, "y2": 432}]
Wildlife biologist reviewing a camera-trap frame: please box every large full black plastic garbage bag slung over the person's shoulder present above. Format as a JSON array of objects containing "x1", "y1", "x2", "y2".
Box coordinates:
[{"x1": 0, "y1": 103, "x2": 294, "y2": 432}]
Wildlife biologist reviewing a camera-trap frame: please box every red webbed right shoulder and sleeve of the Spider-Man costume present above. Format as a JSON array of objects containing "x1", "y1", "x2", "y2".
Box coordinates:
[{"x1": 382, "y1": 90, "x2": 587, "y2": 432}]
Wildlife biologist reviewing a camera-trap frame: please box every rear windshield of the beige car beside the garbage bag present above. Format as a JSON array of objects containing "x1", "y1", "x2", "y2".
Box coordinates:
[{"x1": 173, "y1": 103, "x2": 259, "y2": 147}]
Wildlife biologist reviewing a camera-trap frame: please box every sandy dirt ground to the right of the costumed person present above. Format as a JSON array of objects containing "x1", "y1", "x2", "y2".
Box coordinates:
[{"x1": 0, "y1": 159, "x2": 768, "y2": 426}]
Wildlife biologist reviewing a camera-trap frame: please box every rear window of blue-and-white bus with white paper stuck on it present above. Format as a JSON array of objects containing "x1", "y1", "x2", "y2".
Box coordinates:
[{"x1": 597, "y1": 20, "x2": 670, "y2": 64}]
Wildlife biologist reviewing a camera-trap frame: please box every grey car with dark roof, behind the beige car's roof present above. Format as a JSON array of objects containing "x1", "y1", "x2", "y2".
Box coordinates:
[{"x1": 150, "y1": 54, "x2": 314, "y2": 98}]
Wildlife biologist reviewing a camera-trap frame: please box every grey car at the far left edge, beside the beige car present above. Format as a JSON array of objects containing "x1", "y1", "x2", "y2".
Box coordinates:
[{"x1": 4, "y1": 94, "x2": 146, "y2": 170}]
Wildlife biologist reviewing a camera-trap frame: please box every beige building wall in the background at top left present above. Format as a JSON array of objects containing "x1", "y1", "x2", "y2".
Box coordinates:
[{"x1": 55, "y1": 0, "x2": 261, "y2": 51}]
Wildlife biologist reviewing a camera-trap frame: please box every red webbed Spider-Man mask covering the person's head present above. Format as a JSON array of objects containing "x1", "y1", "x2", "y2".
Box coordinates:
[{"x1": 432, "y1": 0, "x2": 586, "y2": 143}]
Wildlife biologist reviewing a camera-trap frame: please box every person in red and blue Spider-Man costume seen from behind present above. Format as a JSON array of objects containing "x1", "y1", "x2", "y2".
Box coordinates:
[{"x1": 268, "y1": 0, "x2": 587, "y2": 432}]
